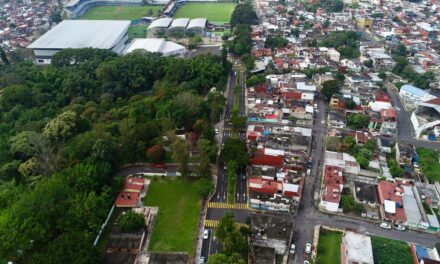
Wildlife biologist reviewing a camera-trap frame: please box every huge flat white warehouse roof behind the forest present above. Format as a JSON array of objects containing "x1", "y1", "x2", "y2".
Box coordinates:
[{"x1": 28, "y1": 20, "x2": 131, "y2": 49}]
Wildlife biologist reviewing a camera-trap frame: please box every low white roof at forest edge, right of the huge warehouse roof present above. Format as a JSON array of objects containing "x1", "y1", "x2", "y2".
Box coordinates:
[{"x1": 124, "y1": 38, "x2": 186, "y2": 57}]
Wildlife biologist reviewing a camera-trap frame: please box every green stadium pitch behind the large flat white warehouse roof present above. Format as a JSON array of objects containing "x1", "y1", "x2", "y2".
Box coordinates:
[{"x1": 81, "y1": 6, "x2": 163, "y2": 20}]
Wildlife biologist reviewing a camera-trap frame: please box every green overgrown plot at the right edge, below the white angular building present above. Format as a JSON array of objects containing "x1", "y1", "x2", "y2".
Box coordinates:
[{"x1": 417, "y1": 148, "x2": 440, "y2": 183}]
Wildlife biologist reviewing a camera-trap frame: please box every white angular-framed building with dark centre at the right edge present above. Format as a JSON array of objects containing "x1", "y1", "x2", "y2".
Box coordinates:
[{"x1": 411, "y1": 97, "x2": 440, "y2": 138}]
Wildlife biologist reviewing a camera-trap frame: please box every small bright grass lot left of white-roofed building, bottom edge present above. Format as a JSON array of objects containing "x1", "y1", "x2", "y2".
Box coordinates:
[{"x1": 316, "y1": 229, "x2": 342, "y2": 264}]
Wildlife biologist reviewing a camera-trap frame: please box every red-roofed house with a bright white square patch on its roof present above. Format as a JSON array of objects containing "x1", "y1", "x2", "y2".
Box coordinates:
[{"x1": 377, "y1": 181, "x2": 407, "y2": 224}]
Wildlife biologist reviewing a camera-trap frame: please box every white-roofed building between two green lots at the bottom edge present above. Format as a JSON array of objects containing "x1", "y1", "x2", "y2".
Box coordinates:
[{"x1": 341, "y1": 231, "x2": 374, "y2": 264}]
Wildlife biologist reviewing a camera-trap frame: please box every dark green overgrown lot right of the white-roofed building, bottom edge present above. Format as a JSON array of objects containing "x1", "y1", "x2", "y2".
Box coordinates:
[{"x1": 371, "y1": 236, "x2": 413, "y2": 264}]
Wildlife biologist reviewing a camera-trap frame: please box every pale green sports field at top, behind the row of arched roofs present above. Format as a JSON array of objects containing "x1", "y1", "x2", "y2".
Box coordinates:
[{"x1": 174, "y1": 3, "x2": 236, "y2": 23}]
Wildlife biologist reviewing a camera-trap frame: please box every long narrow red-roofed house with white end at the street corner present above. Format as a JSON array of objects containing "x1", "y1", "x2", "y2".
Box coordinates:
[{"x1": 319, "y1": 165, "x2": 344, "y2": 212}]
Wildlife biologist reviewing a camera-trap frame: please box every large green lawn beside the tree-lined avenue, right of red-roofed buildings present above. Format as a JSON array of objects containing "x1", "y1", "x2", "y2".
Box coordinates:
[{"x1": 145, "y1": 177, "x2": 201, "y2": 256}]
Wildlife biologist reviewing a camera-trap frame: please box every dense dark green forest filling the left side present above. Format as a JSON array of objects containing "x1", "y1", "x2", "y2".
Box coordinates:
[{"x1": 0, "y1": 49, "x2": 231, "y2": 263}]
